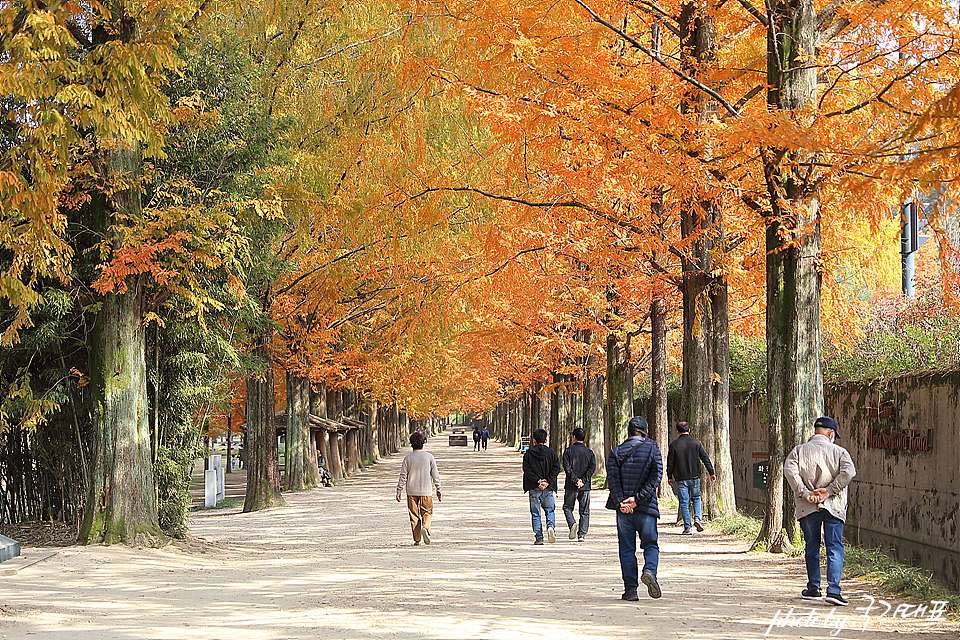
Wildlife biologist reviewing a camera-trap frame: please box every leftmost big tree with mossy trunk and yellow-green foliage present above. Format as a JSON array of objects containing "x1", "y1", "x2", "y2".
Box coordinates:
[{"x1": 0, "y1": 2, "x2": 236, "y2": 542}]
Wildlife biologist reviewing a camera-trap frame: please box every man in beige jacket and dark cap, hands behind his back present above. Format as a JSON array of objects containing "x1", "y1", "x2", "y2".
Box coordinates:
[{"x1": 783, "y1": 416, "x2": 857, "y2": 606}]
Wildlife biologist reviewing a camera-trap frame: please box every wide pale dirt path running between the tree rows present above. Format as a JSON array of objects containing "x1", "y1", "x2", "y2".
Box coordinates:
[{"x1": 0, "y1": 436, "x2": 960, "y2": 640}]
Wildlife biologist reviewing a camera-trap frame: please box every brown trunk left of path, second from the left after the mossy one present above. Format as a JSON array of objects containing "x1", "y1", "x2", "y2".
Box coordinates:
[{"x1": 243, "y1": 332, "x2": 283, "y2": 512}]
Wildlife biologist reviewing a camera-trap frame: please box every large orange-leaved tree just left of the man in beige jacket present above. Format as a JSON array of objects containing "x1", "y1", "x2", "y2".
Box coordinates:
[{"x1": 568, "y1": 0, "x2": 957, "y2": 550}]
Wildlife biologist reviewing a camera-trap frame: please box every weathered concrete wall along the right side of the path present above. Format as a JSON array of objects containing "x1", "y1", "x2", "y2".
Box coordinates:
[{"x1": 730, "y1": 371, "x2": 960, "y2": 588}]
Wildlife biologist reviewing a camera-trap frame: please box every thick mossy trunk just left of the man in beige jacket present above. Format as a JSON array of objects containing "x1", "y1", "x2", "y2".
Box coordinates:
[{"x1": 754, "y1": 0, "x2": 823, "y2": 552}]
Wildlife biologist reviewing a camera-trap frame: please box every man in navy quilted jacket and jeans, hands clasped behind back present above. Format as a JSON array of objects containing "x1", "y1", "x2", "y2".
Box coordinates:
[{"x1": 607, "y1": 416, "x2": 663, "y2": 600}]
